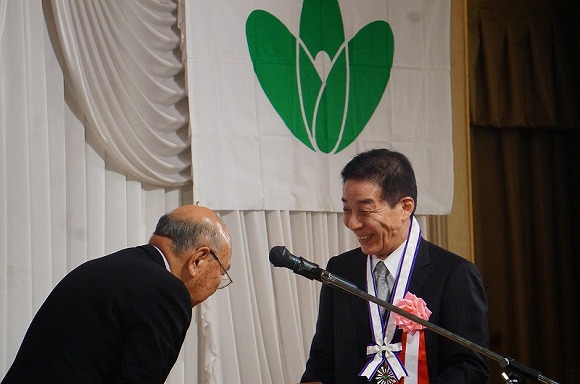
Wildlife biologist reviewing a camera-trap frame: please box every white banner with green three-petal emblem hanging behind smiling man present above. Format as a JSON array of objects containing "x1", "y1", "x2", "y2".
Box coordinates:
[{"x1": 185, "y1": 0, "x2": 453, "y2": 214}]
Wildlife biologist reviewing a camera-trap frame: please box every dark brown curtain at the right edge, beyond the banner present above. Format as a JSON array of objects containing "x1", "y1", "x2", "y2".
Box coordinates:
[{"x1": 468, "y1": 0, "x2": 580, "y2": 383}]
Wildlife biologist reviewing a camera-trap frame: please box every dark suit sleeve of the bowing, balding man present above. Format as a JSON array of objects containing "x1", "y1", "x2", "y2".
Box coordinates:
[{"x1": 118, "y1": 280, "x2": 191, "y2": 383}]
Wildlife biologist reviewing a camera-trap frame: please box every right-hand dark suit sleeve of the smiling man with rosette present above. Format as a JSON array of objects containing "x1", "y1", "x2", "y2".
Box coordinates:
[{"x1": 433, "y1": 261, "x2": 489, "y2": 384}]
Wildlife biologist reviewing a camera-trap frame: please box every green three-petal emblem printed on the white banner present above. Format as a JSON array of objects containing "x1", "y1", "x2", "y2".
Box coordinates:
[{"x1": 246, "y1": 0, "x2": 395, "y2": 153}]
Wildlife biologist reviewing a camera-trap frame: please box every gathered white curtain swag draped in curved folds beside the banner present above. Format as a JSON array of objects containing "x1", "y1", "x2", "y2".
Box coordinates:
[{"x1": 52, "y1": 0, "x2": 191, "y2": 186}]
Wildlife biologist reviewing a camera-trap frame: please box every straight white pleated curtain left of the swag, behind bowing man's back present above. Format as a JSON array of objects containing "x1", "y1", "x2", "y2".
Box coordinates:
[{"x1": 0, "y1": 0, "x2": 191, "y2": 377}]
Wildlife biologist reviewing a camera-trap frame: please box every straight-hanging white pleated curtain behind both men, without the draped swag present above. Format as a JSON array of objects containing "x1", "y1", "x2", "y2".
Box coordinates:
[{"x1": 0, "y1": 0, "x2": 430, "y2": 384}]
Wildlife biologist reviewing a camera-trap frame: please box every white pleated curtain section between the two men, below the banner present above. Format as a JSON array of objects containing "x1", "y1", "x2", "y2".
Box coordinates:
[{"x1": 177, "y1": 211, "x2": 356, "y2": 384}]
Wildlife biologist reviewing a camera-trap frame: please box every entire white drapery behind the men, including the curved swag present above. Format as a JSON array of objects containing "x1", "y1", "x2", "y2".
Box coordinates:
[{"x1": 0, "y1": 0, "x2": 428, "y2": 384}]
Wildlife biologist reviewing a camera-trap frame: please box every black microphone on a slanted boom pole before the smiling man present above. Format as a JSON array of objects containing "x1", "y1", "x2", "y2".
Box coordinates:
[{"x1": 270, "y1": 246, "x2": 559, "y2": 384}]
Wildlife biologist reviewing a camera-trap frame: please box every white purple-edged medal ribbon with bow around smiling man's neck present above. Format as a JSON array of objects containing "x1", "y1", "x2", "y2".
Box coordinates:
[{"x1": 359, "y1": 217, "x2": 425, "y2": 384}]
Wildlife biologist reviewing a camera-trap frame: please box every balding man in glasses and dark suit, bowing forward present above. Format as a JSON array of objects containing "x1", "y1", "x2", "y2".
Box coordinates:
[{"x1": 2, "y1": 205, "x2": 232, "y2": 384}]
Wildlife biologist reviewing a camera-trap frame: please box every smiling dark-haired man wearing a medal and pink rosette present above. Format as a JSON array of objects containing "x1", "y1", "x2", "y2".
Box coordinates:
[{"x1": 301, "y1": 149, "x2": 489, "y2": 384}]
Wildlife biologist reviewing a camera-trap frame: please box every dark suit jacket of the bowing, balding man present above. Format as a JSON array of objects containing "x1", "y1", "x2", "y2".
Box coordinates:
[{"x1": 2, "y1": 245, "x2": 191, "y2": 384}]
